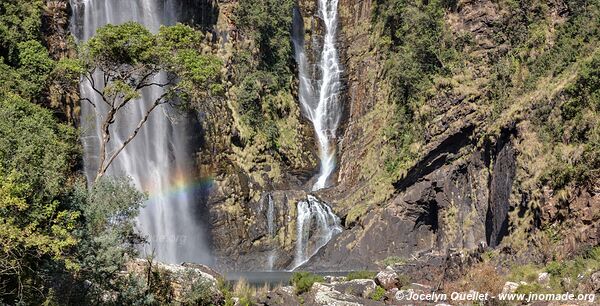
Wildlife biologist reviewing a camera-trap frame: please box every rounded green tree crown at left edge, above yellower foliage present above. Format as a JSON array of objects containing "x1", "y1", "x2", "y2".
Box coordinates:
[{"x1": 0, "y1": 93, "x2": 78, "y2": 205}]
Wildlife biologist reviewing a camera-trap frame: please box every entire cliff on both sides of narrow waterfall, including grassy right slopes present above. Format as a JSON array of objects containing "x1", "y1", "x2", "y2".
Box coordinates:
[{"x1": 199, "y1": 0, "x2": 600, "y2": 270}]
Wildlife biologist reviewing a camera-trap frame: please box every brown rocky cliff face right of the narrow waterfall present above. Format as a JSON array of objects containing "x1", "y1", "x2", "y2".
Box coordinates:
[{"x1": 298, "y1": 0, "x2": 600, "y2": 269}]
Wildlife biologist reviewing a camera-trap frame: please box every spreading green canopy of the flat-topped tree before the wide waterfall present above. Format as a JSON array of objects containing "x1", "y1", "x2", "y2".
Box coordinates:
[{"x1": 79, "y1": 22, "x2": 223, "y2": 105}]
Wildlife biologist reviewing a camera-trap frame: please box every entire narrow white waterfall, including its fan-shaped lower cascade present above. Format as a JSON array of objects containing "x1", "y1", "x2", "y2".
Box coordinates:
[{"x1": 292, "y1": 0, "x2": 342, "y2": 270}]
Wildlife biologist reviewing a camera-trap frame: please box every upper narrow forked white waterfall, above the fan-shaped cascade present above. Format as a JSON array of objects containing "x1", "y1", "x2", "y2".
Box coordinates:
[{"x1": 293, "y1": 0, "x2": 342, "y2": 191}]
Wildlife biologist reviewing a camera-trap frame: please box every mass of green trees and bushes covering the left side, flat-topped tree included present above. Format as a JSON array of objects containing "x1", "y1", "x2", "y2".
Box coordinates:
[{"x1": 0, "y1": 0, "x2": 223, "y2": 305}]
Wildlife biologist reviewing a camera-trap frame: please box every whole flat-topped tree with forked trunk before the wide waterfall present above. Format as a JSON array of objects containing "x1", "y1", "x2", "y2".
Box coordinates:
[{"x1": 64, "y1": 22, "x2": 222, "y2": 182}]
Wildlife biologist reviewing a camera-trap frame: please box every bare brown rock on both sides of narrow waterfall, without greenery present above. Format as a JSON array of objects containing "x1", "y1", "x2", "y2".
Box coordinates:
[{"x1": 186, "y1": 0, "x2": 600, "y2": 274}]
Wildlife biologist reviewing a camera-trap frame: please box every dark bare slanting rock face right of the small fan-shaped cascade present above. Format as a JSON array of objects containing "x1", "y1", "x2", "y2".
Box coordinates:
[{"x1": 307, "y1": 128, "x2": 514, "y2": 269}]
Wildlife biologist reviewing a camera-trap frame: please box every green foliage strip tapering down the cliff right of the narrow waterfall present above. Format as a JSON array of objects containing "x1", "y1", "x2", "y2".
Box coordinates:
[{"x1": 372, "y1": 0, "x2": 466, "y2": 175}]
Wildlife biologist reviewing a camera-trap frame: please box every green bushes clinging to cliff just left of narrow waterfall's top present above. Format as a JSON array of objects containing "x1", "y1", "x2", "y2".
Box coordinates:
[{"x1": 233, "y1": 0, "x2": 294, "y2": 152}]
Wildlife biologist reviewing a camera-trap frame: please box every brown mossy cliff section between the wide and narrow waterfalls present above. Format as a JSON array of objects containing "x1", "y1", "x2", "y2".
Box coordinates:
[{"x1": 198, "y1": 1, "x2": 316, "y2": 271}]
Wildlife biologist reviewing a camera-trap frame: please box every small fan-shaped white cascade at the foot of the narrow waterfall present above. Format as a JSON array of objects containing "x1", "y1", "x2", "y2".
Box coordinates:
[{"x1": 292, "y1": 195, "x2": 342, "y2": 270}]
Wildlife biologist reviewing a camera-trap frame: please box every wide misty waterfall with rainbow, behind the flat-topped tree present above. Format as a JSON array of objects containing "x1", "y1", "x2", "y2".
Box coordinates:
[{"x1": 71, "y1": 0, "x2": 211, "y2": 263}]
